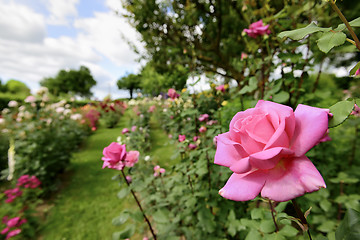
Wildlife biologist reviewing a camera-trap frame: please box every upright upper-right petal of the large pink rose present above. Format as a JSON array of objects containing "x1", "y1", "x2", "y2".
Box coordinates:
[{"x1": 291, "y1": 104, "x2": 329, "y2": 157}]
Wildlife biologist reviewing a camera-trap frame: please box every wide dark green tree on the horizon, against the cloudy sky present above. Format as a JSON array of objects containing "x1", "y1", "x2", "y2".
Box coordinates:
[{"x1": 40, "y1": 66, "x2": 96, "y2": 97}]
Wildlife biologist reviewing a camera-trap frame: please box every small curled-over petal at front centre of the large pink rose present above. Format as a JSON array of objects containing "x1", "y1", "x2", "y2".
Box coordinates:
[{"x1": 249, "y1": 147, "x2": 294, "y2": 169}]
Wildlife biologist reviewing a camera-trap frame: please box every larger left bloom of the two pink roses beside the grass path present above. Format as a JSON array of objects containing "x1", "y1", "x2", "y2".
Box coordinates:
[{"x1": 101, "y1": 142, "x2": 126, "y2": 170}]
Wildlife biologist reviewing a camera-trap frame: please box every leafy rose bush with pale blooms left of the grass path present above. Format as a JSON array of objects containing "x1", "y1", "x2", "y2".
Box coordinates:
[{"x1": 2, "y1": 97, "x2": 88, "y2": 194}]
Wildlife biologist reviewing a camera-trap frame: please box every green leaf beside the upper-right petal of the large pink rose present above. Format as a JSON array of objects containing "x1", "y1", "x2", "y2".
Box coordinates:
[{"x1": 329, "y1": 100, "x2": 355, "y2": 128}]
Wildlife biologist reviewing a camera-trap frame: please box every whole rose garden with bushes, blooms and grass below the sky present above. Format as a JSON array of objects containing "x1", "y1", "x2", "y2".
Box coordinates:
[{"x1": 0, "y1": 0, "x2": 360, "y2": 240}]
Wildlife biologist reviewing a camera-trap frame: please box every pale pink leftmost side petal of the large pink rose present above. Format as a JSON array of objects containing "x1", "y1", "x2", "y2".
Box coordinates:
[{"x1": 214, "y1": 132, "x2": 248, "y2": 167}]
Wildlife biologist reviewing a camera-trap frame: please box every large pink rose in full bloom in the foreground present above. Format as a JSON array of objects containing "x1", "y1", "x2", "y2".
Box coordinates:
[{"x1": 215, "y1": 100, "x2": 329, "y2": 202}]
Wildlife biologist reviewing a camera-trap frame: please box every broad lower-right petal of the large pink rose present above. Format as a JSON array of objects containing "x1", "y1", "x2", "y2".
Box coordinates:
[{"x1": 261, "y1": 156, "x2": 326, "y2": 202}]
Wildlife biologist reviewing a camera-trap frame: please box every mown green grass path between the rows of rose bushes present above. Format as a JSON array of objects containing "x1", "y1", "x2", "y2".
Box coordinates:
[{"x1": 39, "y1": 114, "x2": 174, "y2": 240}]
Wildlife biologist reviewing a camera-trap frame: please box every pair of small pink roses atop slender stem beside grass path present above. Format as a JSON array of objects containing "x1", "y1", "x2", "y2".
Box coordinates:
[{"x1": 101, "y1": 142, "x2": 139, "y2": 170}]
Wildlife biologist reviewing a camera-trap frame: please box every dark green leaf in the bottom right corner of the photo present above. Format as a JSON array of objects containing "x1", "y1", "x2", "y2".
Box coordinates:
[{"x1": 335, "y1": 209, "x2": 360, "y2": 240}]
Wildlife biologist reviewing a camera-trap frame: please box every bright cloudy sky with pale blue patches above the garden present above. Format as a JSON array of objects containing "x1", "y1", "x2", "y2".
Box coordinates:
[{"x1": 0, "y1": 0, "x2": 144, "y2": 99}]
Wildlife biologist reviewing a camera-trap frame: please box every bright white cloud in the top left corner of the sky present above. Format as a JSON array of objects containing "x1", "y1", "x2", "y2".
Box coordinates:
[{"x1": 0, "y1": 0, "x2": 46, "y2": 42}]
